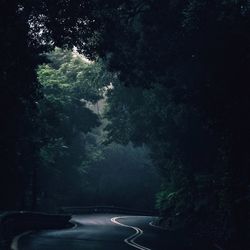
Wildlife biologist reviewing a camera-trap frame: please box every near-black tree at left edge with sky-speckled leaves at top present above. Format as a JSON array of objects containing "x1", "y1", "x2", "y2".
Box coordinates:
[{"x1": 0, "y1": 0, "x2": 98, "y2": 209}]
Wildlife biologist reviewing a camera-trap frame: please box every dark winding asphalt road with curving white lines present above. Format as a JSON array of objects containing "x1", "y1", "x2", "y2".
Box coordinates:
[{"x1": 13, "y1": 214, "x2": 192, "y2": 250}]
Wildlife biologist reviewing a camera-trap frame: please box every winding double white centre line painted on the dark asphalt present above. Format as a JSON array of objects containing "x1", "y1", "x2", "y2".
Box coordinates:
[{"x1": 111, "y1": 216, "x2": 151, "y2": 250}]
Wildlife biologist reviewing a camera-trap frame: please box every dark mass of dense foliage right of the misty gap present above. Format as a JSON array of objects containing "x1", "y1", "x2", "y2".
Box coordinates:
[{"x1": 84, "y1": 0, "x2": 250, "y2": 249}]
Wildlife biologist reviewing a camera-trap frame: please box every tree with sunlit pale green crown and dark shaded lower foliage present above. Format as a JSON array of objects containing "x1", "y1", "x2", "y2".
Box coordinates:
[{"x1": 37, "y1": 48, "x2": 108, "y2": 208}]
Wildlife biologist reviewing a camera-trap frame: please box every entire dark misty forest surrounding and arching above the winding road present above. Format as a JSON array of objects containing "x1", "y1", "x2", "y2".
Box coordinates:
[{"x1": 0, "y1": 0, "x2": 250, "y2": 250}]
